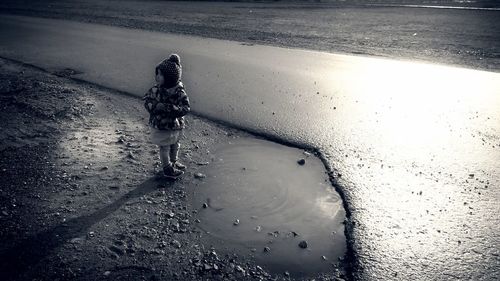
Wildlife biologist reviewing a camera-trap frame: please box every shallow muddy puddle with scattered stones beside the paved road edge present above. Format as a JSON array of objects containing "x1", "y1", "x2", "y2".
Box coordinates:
[{"x1": 189, "y1": 139, "x2": 346, "y2": 277}]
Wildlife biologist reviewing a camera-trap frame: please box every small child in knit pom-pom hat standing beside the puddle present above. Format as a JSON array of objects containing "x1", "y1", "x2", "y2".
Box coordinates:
[{"x1": 143, "y1": 54, "x2": 190, "y2": 178}]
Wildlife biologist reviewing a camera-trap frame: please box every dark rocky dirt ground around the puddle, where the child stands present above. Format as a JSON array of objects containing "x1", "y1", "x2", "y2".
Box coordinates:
[{"x1": 0, "y1": 57, "x2": 343, "y2": 280}]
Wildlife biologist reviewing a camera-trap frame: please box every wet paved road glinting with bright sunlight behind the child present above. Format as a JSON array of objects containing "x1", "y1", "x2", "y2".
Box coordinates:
[{"x1": 3, "y1": 8, "x2": 500, "y2": 280}]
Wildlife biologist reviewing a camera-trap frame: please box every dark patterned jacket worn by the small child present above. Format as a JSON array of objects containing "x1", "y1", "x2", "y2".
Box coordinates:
[{"x1": 146, "y1": 82, "x2": 191, "y2": 130}]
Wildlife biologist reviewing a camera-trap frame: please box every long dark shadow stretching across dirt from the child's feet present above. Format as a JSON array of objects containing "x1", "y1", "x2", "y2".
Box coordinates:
[{"x1": 0, "y1": 177, "x2": 174, "y2": 280}]
